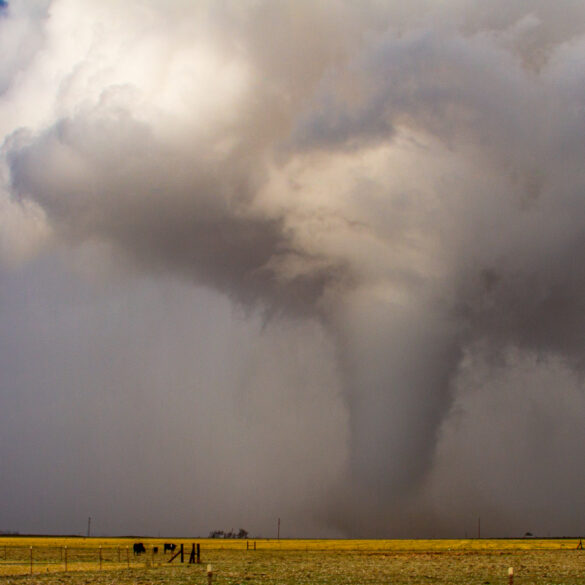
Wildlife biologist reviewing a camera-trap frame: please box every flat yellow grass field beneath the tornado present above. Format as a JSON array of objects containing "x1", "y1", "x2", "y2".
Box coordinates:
[{"x1": 0, "y1": 537, "x2": 585, "y2": 585}]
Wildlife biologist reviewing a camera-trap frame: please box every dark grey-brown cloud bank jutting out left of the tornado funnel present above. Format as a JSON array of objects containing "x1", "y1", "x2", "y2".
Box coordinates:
[{"x1": 8, "y1": 105, "x2": 343, "y2": 312}]
